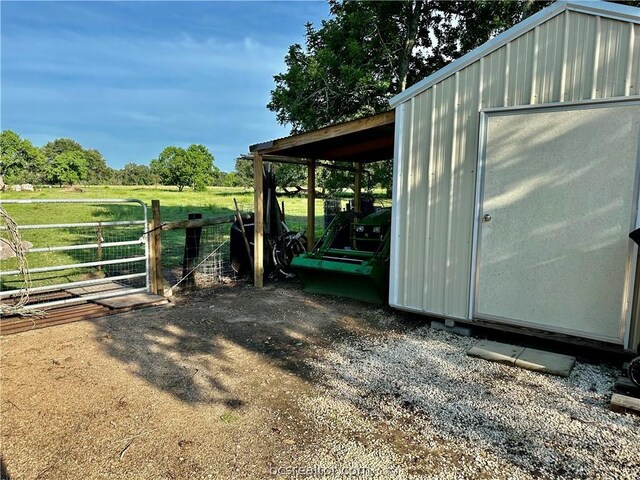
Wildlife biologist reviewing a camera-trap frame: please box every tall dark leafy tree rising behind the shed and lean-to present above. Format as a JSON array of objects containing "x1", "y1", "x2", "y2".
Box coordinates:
[{"x1": 267, "y1": 0, "x2": 640, "y2": 194}]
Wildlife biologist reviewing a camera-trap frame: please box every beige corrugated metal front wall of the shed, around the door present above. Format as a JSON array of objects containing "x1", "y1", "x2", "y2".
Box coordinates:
[{"x1": 390, "y1": 10, "x2": 640, "y2": 319}]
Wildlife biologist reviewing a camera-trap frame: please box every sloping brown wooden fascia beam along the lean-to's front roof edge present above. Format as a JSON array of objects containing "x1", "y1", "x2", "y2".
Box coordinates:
[{"x1": 249, "y1": 110, "x2": 396, "y2": 154}]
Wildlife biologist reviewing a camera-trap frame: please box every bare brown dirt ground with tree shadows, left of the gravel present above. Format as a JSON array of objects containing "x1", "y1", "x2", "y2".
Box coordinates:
[{"x1": 0, "y1": 286, "x2": 404, "y2": 479}]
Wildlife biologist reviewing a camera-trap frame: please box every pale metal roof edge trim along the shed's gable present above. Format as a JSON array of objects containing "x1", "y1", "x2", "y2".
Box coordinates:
[{"x1": 389, "y1": 0, "x2": 640, "y2": 108}]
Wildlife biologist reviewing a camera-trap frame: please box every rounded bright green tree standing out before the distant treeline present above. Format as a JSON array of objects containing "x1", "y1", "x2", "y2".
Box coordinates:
[{"x1": 150, "y1": 145, "x2": 219, "y2": 192}]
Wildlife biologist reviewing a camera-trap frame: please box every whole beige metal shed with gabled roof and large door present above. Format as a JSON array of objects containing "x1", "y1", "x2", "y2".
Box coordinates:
[{"x1": 389, "y1": 1, "x2": 640, "y2": 349}]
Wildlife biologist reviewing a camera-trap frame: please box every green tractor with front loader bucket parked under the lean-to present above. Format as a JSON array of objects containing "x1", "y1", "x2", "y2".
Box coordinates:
[{"x1": 291, "y1": 208, "x2": 391, "y2": 303}]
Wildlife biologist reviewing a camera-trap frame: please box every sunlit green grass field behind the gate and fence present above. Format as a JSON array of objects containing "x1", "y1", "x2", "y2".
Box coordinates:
[{"x1": 0, "y1": 186, "x2": 323, "y2": 289}]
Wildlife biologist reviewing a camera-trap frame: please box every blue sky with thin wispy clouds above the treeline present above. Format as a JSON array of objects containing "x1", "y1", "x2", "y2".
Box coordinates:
[{"x1": 0, "y1": 1, "x2": 328, "y2": 171}]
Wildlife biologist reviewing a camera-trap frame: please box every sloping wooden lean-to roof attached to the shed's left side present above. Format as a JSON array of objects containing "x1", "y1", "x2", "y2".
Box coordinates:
[{"x1": 249, "y1": 110, "x2": 396, "y2": 163}]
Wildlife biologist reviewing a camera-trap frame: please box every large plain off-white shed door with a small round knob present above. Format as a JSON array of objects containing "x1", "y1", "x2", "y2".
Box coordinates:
[{"x1": 474, "y1": 102, "x2": 640, "y2": 343}]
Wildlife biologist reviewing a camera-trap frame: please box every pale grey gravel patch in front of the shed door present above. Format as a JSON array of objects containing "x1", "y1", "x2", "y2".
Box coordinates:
[{"x1": 301, "y1": 316, "x2": 640, "y2": 479}]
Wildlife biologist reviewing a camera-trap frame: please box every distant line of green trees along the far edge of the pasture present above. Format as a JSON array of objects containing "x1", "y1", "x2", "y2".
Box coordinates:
[{"x1": 0, "y1": 130, "x2": 392, "y2": 194}]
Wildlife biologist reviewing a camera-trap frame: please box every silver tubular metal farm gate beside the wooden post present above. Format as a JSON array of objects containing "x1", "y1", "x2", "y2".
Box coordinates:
[{"x1": 0, "y1": 199, "x2": 150, "y2": 309}]
